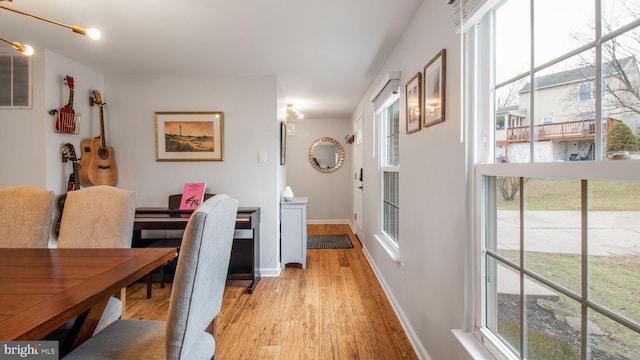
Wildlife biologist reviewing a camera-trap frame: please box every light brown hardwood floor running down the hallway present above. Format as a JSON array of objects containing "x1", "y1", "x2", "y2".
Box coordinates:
[{"x1": 127, "y1": 225, "x2": 417, "y2": 360}]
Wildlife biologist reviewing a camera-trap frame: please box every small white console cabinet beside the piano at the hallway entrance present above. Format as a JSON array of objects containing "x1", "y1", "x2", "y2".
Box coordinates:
[{"x1": 280, "y1": 197, "x2": 307, "y2": 269}]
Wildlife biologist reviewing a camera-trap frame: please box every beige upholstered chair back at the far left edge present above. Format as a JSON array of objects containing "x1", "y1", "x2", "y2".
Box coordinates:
[{"x1": 0, "y1": 185, "x2": 55, "y2": 248}]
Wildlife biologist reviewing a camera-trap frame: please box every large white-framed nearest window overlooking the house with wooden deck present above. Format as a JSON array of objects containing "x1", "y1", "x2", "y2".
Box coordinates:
[{"x1": 465, "y1": 0, "x2": 640, "y2": 359}]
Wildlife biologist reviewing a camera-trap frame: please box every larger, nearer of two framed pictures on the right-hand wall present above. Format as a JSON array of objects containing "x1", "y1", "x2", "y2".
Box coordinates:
[{"x1": 422, "y1": 49, "x2": 447, "y2": 127}]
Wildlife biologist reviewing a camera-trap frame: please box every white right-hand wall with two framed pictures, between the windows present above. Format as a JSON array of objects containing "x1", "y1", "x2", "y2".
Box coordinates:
[{"x1": 352, "y1": 1, "x2": 468, "y2": 359}]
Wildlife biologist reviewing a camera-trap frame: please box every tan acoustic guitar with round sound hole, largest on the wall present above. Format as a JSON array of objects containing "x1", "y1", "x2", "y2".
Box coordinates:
[{"x1": 80, "y1": 90, "x2": 118, "y2": 186}]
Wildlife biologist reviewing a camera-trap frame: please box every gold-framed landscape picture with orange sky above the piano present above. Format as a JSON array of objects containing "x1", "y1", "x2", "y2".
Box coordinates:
[{"x1": 155, "y1": 111, "x2": 224, "y2": 161}]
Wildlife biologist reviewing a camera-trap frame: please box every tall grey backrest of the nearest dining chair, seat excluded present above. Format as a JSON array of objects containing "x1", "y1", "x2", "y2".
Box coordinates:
[{"x1": 166, "y1": 195, "x2": 238, "y2": 360}]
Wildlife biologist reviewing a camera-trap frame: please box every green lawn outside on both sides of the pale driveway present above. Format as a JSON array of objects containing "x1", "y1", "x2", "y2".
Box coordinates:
[{"x1": 498, "y1": 178, "x2": 640, "y2": 359}]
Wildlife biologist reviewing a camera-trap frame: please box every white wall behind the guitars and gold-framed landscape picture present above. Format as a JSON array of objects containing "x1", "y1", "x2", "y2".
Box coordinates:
[{"x1": 0, "y1": 62, "x2": 285, "y2": 276}]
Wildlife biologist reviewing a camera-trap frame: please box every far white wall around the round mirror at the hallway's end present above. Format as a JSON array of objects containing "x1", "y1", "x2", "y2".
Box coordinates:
[{"x1": 287, "y1": 119, "x2": 353, "y2": 224}]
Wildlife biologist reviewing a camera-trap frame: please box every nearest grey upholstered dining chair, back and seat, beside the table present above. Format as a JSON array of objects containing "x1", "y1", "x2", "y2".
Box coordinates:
[{"x1": 65, "y1": 195, "x2": 238, "y2": 360}]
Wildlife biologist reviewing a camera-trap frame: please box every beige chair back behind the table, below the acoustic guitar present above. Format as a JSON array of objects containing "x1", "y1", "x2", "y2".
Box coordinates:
[{"x1": 58, "y1": 185, "x2": 136, "y2": 248}]
